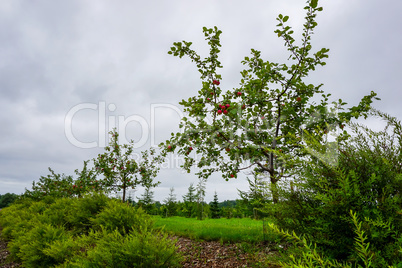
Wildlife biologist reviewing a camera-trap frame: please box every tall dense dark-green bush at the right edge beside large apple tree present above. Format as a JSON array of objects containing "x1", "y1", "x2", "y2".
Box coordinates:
[{"x1": 269, "y1": 111, "x2": 402, "y2": 267}]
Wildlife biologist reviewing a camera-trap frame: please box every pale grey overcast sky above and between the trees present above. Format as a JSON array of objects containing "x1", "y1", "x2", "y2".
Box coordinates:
[{"x1": 0, "y1": 0, "x2": 402, "y2": 201}]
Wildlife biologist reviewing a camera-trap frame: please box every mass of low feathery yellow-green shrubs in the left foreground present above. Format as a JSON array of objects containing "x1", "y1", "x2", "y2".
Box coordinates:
[{"x1": 0, "y1": 195, "x2": 179, "y2": 267}]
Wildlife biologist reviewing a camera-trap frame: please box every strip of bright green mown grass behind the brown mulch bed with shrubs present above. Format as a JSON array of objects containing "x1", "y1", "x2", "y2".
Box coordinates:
[{"x1": 153, "y1": 216, "x2": 276, "y2": 243}]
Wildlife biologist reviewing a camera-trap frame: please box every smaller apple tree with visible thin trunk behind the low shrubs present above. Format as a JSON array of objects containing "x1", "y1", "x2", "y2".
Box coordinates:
[{"x1": 94, "y1": 130, "x2": 164, "y2": 202}]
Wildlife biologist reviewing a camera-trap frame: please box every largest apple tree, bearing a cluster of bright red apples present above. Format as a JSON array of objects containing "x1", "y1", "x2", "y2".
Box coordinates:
[{"x1": 161, "y1": 0, "x2": 378, "y2": 203}]
